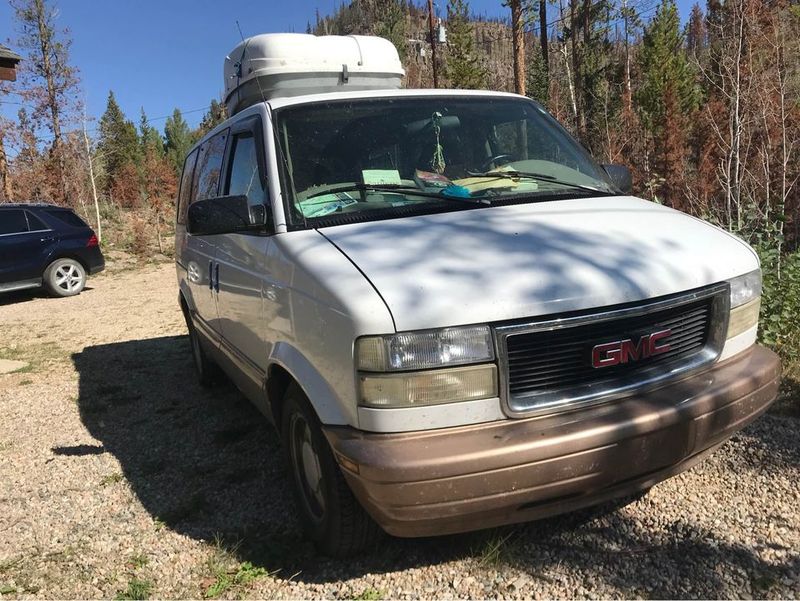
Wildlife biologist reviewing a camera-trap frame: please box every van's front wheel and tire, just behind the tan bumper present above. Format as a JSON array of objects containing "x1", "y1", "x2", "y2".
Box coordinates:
[{"x1": 281, "y1": 384, "x2": 381, "y2": 557}]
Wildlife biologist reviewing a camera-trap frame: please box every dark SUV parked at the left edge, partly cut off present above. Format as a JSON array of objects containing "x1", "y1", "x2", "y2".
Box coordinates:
[{"x1": 0, "y1": 204, "x2": 105, "y2": 296}]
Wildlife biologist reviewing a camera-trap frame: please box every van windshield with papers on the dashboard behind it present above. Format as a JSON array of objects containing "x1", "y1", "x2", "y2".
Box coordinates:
[{"x1": 275, "y1": 96, "x2": 615, "y2": 227}]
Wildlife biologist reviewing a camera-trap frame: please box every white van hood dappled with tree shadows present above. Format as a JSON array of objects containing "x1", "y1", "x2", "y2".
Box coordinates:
[{"x1": 320, "y1": 197, "x2": 758, "y2": 331}]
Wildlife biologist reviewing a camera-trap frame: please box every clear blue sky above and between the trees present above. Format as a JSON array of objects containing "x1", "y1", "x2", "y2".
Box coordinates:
[{"x1": 0, "y1": 0, "x2": 692, "y2": 136}]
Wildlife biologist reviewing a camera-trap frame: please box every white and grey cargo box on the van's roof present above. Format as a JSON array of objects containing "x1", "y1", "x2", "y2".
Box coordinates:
[{"x1": 225, "y1": 33, "x2": 405, "y2": 115}]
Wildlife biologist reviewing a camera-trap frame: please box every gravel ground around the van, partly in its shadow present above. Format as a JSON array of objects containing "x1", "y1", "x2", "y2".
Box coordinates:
[{"x1": 0, "y1": 254, "x2": 800, "y2": 599}]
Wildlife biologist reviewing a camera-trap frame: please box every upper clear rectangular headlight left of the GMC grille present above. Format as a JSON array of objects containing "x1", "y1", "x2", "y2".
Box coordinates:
[{"x1": 356, "y1": 326, "x2": 494, "y2": 372}]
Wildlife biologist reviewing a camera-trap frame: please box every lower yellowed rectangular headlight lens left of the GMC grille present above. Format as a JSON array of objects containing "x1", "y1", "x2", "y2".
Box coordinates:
[{"x1": 360, "y1": 365, "x2": 497, "y2": 407}]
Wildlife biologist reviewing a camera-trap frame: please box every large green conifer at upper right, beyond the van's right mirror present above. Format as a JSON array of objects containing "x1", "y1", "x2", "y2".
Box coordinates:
[{"x1": 636, "y1": 0, "x2": 699, "y2": 132}]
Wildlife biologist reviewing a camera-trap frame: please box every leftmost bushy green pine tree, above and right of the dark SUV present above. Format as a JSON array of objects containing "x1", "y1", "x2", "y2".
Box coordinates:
[{"x1": 97, "y1": 91, "x2": 141, "y2": 192}]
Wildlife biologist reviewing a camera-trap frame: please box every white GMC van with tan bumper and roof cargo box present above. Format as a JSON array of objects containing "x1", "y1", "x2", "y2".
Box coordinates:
[{"x1": 176, "y1": 34, "x2": 780, "y2": 555}]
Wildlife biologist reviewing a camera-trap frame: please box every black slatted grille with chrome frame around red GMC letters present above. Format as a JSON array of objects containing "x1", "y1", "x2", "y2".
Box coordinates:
[{"x1": 497, "y1": 287, "x2": 727, "y2": 412}]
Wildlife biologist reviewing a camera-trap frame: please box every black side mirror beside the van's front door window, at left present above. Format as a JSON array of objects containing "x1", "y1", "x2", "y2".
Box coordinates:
[{"x1": 186, "y1": 196, "x2": 267, "y2": 236}]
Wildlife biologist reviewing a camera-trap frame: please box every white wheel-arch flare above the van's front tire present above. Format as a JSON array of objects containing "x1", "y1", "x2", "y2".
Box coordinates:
[{"x1": 267, "y1": 342, "x2": 357, "y2": 426}]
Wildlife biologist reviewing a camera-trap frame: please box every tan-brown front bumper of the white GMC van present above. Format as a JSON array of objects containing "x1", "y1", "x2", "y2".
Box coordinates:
[{"x1": 325, "y1": 346, "x2": 780, "y2": 537}]
